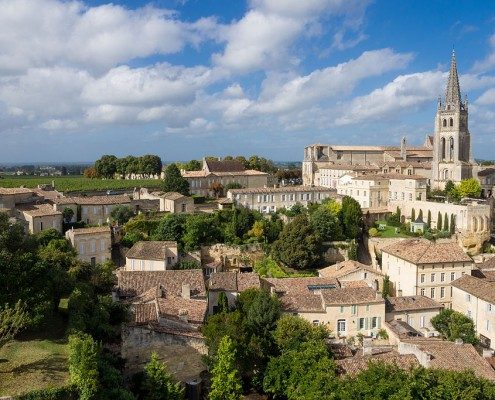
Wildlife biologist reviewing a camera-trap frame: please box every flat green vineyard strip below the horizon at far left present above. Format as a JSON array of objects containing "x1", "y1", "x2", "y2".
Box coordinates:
[{"x1": 0, "y1": 176, "x2": 162, "y2": 192}]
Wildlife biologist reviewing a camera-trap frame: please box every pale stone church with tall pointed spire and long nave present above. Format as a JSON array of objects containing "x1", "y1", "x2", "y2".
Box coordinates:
[{"x1": 303, "y1": 53, "x2": 495, "y2": 196}]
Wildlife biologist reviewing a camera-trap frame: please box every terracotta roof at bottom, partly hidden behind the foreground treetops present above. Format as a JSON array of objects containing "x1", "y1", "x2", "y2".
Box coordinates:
[{"x1": 335, "y1": 350, "x2": 420, "y2": 375}]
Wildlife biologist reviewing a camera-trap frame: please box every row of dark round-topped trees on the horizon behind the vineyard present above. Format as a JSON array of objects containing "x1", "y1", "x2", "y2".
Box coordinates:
[{"x1": 92, "y1": 154, "x2": 162, "y2": 179}]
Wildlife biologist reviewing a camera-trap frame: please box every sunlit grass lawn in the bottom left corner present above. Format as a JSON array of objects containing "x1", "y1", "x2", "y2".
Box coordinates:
[{"x1": 0, "y1": 318, "x2": 69, "y2": 396}]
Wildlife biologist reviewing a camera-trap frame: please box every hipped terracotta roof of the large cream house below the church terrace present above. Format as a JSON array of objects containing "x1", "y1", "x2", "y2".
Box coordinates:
[{"x1": 382, "y1": 239, "x2": 473, "y2": 264}]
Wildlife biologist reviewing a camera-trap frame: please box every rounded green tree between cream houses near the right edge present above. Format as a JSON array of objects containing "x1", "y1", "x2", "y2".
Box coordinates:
[{"x1": 431, "y1": 308, "x2": 478, "y2": 344}]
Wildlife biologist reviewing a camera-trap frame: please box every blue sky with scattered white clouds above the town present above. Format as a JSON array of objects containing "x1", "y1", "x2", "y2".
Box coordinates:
[{"x1": 0, "y1": 0, "x2": 495, "y2": 164}]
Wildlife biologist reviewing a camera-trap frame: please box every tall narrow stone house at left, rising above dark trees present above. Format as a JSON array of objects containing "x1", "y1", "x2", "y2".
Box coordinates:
[{"x1": 65, "y1": 226, "x2": 112, "y2": 265}]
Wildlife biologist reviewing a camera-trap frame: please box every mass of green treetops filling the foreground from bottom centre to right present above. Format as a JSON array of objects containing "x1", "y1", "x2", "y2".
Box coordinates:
[{"x1": 203, "y1": 289, "x2": 495, "y2": 400}]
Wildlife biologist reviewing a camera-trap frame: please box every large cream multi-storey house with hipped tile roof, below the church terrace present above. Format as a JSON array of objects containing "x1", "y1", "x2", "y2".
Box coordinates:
[{"x1": 381, "y1": 239, "x2": 473, "y2": 308}]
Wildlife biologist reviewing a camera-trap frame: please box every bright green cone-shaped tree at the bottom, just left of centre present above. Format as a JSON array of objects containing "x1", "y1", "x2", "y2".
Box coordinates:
[{"x1": 208, "y1": 336, "x2": 242, "y2": 400}]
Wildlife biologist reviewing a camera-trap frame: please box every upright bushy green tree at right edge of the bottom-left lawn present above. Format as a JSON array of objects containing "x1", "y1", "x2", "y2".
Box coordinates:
[{"x1": 69, "y1": 334, "x2": 100, "y2": 400}]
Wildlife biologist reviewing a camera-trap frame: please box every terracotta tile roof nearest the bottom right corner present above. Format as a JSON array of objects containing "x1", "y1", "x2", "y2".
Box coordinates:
[{"x1": 403, "y1": 339, "x2": 495, "y2": 381}]
